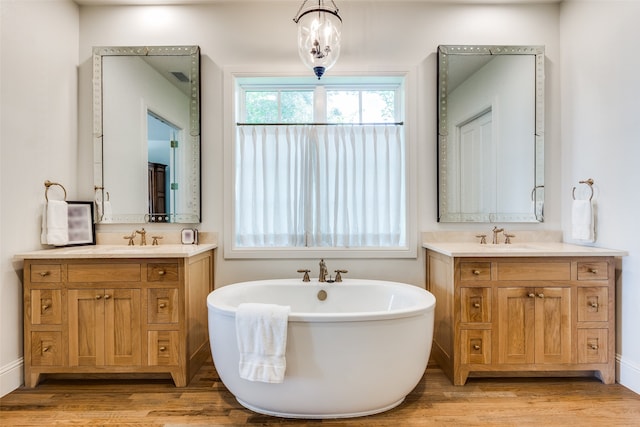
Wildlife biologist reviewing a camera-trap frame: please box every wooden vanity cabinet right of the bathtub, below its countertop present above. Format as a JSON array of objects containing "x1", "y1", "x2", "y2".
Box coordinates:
[{"x1": 426, "y1": 250, "x2": 615, "y2": 385}]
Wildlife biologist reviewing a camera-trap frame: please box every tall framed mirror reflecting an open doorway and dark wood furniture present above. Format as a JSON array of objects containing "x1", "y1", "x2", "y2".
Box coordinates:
[{"x1": 94, "y1": 46, "x2": 200, "y2": 223}]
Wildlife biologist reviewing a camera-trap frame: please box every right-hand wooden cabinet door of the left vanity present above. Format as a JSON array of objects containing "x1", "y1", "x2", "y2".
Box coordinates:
[{"x1": 104, "y1": 289, "x2": 141, "y2": 366}]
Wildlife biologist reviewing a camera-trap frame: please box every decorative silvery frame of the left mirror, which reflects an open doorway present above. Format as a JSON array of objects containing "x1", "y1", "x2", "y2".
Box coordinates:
[{"x1": 93, "y1": 46, "x2": 202, "y2": 224}]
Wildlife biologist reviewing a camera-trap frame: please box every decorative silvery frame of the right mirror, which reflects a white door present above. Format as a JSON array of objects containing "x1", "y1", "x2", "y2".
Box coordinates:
[{"x1": 438, "y1": 45, "x2": 545, "y2": 222}]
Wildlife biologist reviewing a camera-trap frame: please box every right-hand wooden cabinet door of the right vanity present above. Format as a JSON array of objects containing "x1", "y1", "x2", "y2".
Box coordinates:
[{"x1": 535, "y1": 288, "x2": 571, "y2": 363}]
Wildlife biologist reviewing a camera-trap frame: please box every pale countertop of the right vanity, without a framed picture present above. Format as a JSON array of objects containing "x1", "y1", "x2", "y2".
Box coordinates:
[{"x1": 422, "y1": 241, "x2": 628, "y2": 257}]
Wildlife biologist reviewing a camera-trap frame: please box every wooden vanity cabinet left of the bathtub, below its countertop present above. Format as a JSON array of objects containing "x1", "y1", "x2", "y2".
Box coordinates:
[{"x1": 24, "y1": 251, "x2": 213, "y2": 387}]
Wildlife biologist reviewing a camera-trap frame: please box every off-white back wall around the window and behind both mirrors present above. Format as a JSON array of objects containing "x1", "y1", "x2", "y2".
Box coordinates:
[{"x1": 79, "y1": 1, "x2": 560, "y2": 286}]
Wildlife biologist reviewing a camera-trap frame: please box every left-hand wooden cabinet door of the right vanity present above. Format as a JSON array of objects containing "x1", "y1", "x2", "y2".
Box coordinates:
[{"x1": 498, "y1": 288, "x2": 536, "y2": 364}]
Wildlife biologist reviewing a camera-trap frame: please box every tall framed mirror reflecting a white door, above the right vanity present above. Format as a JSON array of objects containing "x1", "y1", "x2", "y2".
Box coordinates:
[{"x1": 438, "y1": 45, "x2": 544, "y2": 222}]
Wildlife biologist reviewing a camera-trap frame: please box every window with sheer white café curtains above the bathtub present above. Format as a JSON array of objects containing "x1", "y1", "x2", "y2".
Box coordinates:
[{"x1": 233, "y1": 78, "x2": 407, "y2": 254}]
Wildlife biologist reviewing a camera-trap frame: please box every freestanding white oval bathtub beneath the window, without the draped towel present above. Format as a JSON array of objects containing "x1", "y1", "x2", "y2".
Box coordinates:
[{"x1": 207, "y1": 279, "x2": 435, "y2": 418}]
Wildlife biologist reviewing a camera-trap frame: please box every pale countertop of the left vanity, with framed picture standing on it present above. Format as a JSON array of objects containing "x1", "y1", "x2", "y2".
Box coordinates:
[{"x1": 14, "y1": 243, "x2": 218, "y2": 260}]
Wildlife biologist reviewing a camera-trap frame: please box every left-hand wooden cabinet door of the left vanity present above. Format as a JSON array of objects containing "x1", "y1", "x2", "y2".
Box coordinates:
[{"x1": 68, "y1": 289, "x2": 105, "y2": 366}]
